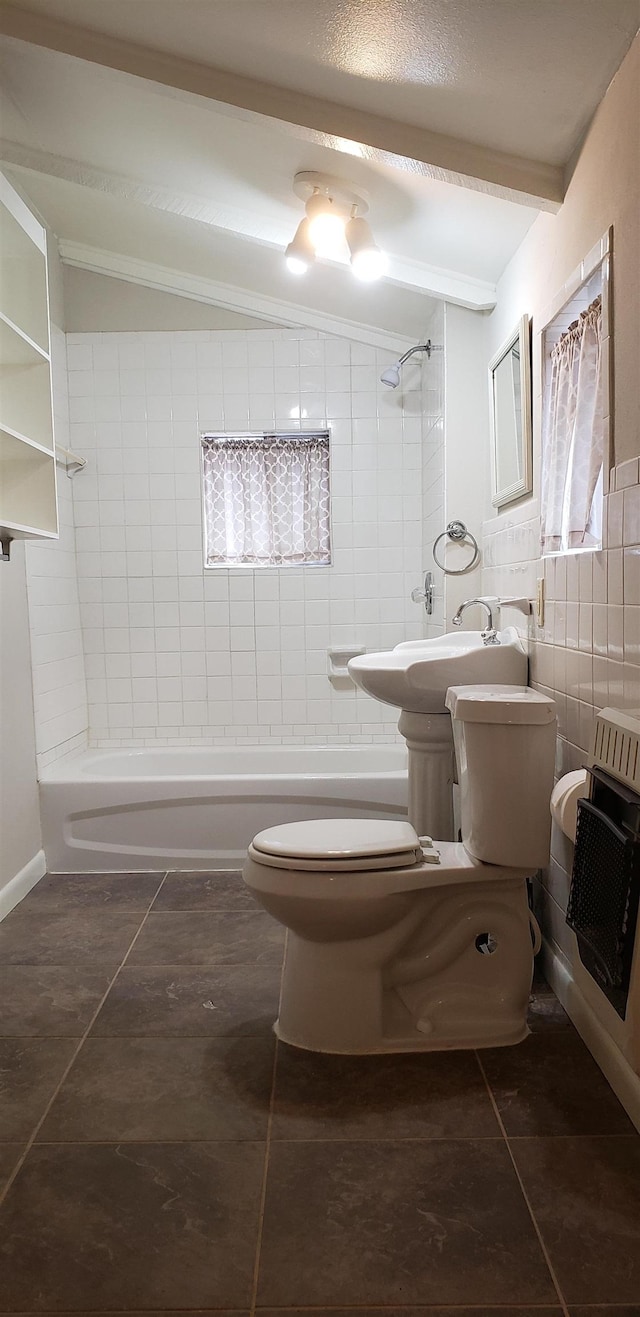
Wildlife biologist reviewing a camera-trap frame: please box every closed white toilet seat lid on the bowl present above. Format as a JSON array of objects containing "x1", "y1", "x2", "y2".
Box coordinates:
[{"x1": 253, "y1": 819, "x2": 419, "y2": 860}]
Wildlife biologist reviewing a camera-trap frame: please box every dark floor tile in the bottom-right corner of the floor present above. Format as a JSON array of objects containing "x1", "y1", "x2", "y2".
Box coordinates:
[{"x1": 511, "y1": 1137, "x2": 640, "y2": 1304}]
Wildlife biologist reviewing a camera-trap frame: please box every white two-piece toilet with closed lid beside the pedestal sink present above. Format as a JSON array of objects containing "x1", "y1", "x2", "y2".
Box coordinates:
[{"x1": 244, "y1": 686, "x2": 556, "y2": 1054}]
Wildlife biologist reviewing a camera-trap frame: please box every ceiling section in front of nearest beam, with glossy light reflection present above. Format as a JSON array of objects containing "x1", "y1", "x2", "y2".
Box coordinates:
[{"x1": 5, "y1": 0, "x2": 640, "y2": 163}]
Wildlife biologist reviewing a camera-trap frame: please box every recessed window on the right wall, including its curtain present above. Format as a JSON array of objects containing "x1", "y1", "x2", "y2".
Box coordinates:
[{"x1": 541, "y1": 236, "x2": 610, "y2": 554}]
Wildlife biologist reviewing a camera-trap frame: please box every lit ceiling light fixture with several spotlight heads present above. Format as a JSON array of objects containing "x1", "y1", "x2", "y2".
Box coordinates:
[{"x1": 284, "y1": 170, "x2": 387, "y2": 282}]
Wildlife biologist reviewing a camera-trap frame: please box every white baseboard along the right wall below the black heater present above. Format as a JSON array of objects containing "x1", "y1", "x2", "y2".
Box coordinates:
[{"x1": 541, "y1": 939, "x2": 640, "y2": 1131}]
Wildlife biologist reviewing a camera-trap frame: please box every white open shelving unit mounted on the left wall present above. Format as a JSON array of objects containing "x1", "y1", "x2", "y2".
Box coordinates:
[{"x1": 0, "y1": 174, "x2": 58, "y2": 541}]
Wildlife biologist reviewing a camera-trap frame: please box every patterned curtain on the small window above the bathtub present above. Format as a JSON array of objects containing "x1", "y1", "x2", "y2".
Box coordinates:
[{"x1": 203, "y1": 433, "x2": 331, "y2": 566}]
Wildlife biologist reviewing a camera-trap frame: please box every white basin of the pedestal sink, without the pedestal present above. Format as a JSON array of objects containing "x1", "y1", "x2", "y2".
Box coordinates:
[{"x1": 349, "y1": 627, "x2": 528, "y2": 714}]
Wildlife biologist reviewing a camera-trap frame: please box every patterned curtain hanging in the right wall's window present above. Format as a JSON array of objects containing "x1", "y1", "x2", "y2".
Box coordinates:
[{"x1": 541, "y1": 296, "x2": 604, "y2": 553}]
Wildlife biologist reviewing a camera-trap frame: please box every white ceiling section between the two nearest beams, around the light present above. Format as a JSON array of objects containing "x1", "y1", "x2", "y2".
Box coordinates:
[{"x1": 0, "y1": 41, "x2": 535, "y2": 284}]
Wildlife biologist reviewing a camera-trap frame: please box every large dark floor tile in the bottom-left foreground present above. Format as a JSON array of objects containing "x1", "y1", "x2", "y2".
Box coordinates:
[{"x1": 0, "y1": 1143, "x2": 265, "y2": 1314}]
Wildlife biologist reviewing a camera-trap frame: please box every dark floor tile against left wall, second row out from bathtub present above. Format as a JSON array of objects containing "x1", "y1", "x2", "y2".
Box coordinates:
[{"x1": 0, "y1": 907, "x2": 141, "y2": 969}]
